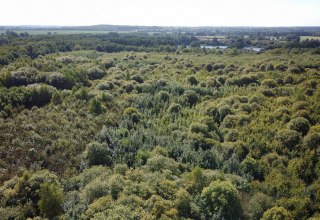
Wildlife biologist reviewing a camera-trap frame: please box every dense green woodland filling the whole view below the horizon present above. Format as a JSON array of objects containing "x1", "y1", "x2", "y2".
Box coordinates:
[{"x1": 0, "y1": 27, "x2": 320, "y2": 220}]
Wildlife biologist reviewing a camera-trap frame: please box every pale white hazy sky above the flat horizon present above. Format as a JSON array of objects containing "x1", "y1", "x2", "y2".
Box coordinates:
[{"x1": 0, "y1": 0, "x2": 320, "y2": 26}]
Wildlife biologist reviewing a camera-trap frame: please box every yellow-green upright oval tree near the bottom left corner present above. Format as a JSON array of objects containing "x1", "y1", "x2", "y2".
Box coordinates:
[{"x1": 38, "y1": 183, "x2": 63, "y2": 219}]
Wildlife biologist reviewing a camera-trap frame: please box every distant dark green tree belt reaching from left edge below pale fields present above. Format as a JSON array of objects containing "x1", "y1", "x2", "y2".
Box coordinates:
[{"x1": 0, "y1": 31, "x2": 197, "y2": 65}]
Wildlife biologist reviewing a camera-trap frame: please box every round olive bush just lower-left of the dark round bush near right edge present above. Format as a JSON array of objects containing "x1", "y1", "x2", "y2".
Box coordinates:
[{"x1": 276, "y1": 129, "x2": 301, "y2": 149}]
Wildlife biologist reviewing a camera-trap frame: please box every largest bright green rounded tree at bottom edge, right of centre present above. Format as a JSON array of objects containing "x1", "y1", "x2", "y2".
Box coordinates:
[{"x1": 201, "y1": 180, "x2": 242, "y2": 219}]
